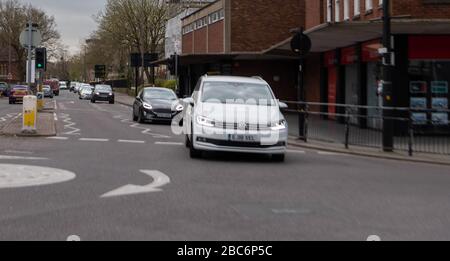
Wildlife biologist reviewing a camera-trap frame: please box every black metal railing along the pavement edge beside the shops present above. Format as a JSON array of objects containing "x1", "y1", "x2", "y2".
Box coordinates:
[{"x1": 285, "y1": 101, "x2": 450, "y2": 156}]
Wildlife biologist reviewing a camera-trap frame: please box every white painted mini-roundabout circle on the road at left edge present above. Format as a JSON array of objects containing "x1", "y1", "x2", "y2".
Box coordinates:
[{"x1": 0, "y1": 164, "x2": 76, "y2": 189}]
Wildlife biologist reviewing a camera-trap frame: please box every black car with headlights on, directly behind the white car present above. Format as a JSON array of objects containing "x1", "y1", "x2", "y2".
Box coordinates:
[{"x1": 133, "y1": 87, "x2": 183, "y2": 123}]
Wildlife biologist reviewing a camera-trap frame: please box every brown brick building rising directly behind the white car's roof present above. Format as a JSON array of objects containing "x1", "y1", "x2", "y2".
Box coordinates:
[{"x1": 180, "y1": 0, "x2": 305, "y2": 100}]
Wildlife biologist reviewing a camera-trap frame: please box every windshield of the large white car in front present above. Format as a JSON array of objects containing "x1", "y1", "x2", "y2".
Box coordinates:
[{"x1": 202, "y1": 82, "x2": 276, "y2": 106}]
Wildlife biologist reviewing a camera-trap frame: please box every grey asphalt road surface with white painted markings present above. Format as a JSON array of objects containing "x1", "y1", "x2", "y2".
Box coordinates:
[{"x1": 0, "y1": 92, "x2": 450, "y2": 241}]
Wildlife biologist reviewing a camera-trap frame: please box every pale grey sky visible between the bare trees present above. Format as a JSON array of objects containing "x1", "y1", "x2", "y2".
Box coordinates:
[{"x1": 19, "y1": 0, "x2": 106, "y2": 54}]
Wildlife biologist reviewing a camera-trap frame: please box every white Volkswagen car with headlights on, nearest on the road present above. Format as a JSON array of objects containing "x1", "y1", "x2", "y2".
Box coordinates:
[{"x1": 183, "y1": 76, "x2": 288, "y2": 161}]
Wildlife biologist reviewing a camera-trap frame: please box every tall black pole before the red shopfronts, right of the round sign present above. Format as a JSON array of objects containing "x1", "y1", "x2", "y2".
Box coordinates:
[{"x1": 382, "y1": 0, "x2": 394, "y2": 152}]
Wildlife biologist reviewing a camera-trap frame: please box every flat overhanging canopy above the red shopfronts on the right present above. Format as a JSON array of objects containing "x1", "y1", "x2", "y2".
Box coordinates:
[{"x1": 265, "y1": 18, "x2": 450, "y2": 56}]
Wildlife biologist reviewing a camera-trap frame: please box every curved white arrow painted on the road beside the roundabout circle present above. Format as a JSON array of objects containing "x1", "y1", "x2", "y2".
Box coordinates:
[{"x1": 101, "y1": 170, "x2": 170, "y2": 198}]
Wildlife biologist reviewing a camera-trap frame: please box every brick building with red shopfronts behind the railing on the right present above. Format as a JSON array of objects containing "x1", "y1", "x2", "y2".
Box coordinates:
[{"x1": 267, "y1": 0, "x2": 450, "y2": 130}]
